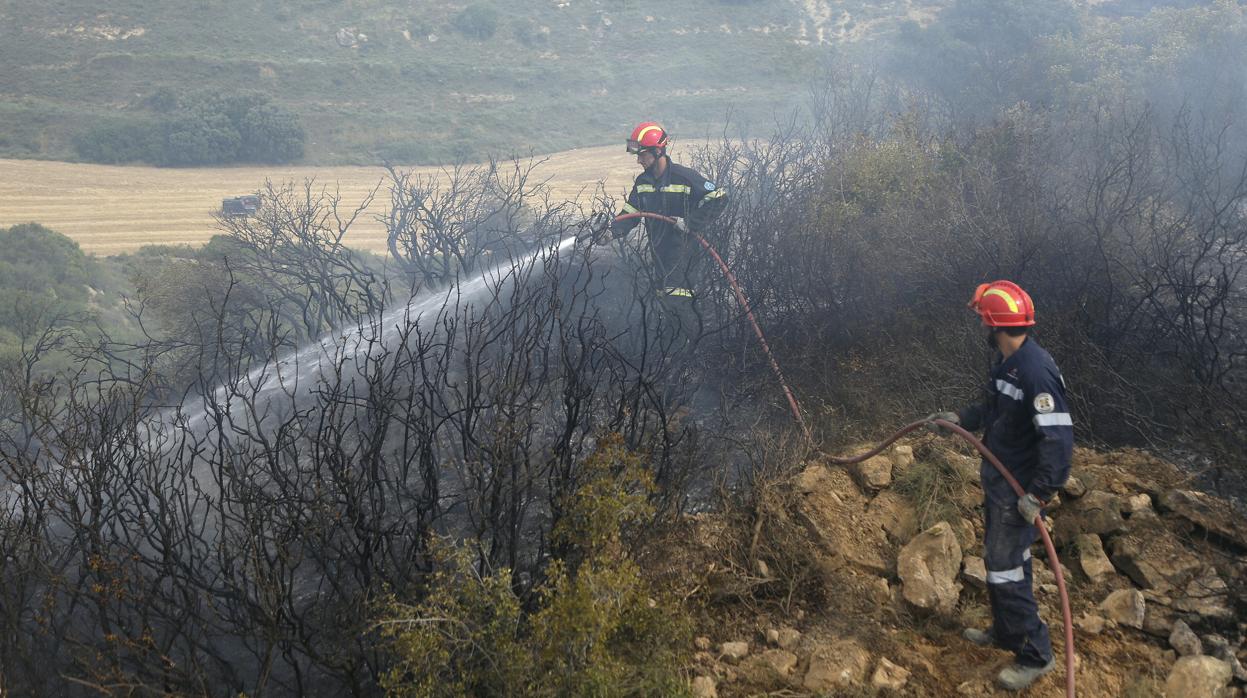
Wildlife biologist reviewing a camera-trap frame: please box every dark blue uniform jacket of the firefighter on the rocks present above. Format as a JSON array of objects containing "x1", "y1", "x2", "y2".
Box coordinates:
[{"x1": 958, "y1": 337, "x2": 1074, "y2": 506}]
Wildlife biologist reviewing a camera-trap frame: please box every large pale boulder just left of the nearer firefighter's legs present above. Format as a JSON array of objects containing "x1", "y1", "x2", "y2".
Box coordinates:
[{"x1": 897, "y1": 521, "x2": 961, "y2": 614}]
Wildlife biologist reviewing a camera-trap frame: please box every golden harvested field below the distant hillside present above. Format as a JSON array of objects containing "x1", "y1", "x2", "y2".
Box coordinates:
[{"x1": 0, "y1": 146, "x2": 638, "y2": 256}]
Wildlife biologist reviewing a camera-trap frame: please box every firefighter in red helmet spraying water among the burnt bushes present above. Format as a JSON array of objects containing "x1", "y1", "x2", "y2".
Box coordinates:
[{"x1": 611, "y1": 121, "x2": 727, "y2": 303}]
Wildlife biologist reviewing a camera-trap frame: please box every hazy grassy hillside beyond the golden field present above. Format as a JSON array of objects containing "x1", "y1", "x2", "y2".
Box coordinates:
[{"x1": 0, "y1": 0, "x2": 928, "y2": 163}]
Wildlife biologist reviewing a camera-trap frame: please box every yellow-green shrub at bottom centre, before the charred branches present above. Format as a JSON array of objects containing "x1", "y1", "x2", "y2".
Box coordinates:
[{"x1": 377, "y1": 437, "x2": 690, "y2": 698}]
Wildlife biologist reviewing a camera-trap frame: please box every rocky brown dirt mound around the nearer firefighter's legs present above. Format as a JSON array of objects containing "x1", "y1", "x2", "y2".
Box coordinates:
[{"x1": 668, "y1": 437, "x2": 1247, "y2": 698}]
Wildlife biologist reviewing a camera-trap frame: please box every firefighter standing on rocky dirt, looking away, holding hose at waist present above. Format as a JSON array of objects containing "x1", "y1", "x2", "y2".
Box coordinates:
[{"x1": 928, "y1": 280, "x2": 1074, "y2": 691}]
